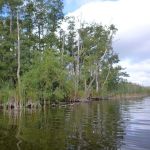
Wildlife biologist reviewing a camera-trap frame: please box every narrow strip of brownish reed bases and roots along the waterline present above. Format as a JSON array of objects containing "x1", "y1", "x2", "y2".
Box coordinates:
[{"x1": 0, "y1": 89, "x2": 150, "y2": 110}]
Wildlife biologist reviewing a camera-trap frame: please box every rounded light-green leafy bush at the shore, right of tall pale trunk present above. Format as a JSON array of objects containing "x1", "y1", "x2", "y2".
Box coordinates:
[{"x1": 22, "y1": 50, "x2": 73, "y2": 100}]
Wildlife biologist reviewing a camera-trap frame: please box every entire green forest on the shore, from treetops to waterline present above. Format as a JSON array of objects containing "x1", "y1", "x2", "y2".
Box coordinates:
[{"x1": 0, "y1": 0, "x2": 149, "y2": 107}]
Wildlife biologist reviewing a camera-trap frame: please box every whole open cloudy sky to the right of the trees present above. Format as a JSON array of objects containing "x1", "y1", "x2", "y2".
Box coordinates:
[{"x1": 64, "y1": 0, "x2": 150, "y2": 86}]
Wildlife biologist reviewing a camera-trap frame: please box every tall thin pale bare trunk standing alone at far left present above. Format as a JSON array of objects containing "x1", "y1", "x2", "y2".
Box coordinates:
[{"x1": 17, "y1": 11, "x2": 22, "y2": 106}]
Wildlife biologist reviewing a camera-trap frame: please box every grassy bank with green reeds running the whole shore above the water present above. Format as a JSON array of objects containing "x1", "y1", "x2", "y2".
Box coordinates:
[{"x1": 0, "y1": 82, "x2": 150, "y2": 109}]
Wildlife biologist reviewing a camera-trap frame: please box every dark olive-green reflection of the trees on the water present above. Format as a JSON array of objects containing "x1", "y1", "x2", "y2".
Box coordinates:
[{"x1": 0, "y1": 101, "x2": 124, "y2": 150}]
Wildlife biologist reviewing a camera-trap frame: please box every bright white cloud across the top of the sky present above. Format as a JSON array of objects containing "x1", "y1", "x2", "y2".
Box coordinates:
[{"x1": 67, "y1": 0, "x2": 150, "y2": 33}]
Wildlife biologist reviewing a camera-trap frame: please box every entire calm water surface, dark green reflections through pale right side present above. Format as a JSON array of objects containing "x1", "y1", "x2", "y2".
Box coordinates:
[{"x1": 0, "y1": 98, "x2": 150, "y2": 150}]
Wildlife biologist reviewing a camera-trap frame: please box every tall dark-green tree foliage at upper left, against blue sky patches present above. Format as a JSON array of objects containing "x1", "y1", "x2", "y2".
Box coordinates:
[{"x1": 0, "y1": 0, "x2": 63, "y2": 88}]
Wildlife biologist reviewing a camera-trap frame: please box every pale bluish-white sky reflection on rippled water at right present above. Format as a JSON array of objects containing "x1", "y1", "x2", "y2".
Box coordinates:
[{"x1": 122, "y1": 99, "x2": 150, "y2": 150}]
